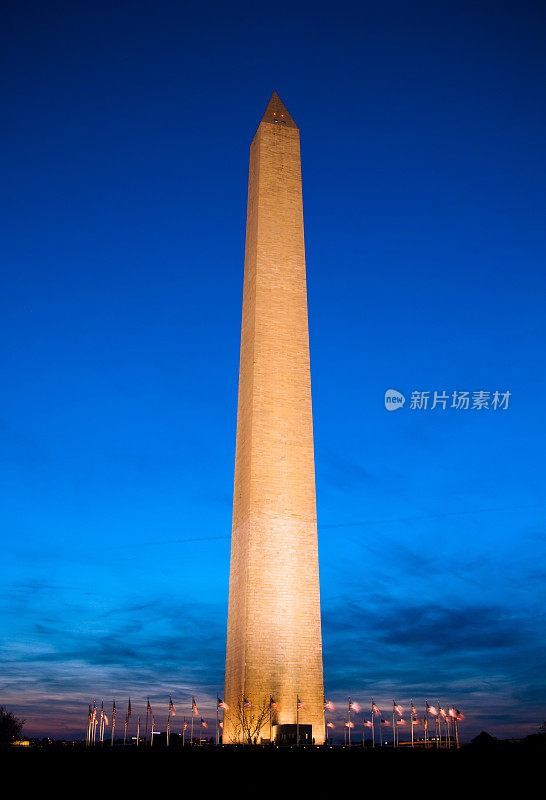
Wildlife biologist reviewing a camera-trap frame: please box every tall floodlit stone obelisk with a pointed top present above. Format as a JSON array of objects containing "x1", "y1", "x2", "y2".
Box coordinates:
[{"x1": 223, "y1": 93, "x2": 324, "y2": 744}]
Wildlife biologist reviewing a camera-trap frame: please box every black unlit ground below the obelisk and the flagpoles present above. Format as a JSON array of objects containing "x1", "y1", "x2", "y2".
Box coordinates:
[{"x1": 0, "y1": 737, "x2": 546, "y2": 798}]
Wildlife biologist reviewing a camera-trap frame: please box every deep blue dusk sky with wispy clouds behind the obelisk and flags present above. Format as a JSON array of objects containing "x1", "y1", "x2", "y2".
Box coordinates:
[{"x1": 0, "y1": 0, "x2": 546, "y2": 738}]
